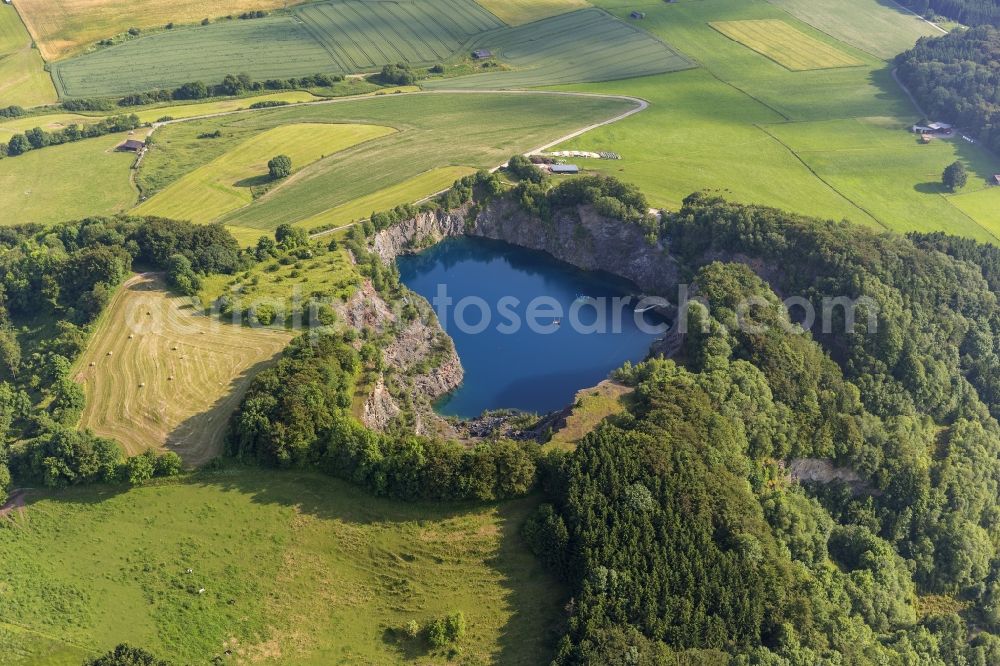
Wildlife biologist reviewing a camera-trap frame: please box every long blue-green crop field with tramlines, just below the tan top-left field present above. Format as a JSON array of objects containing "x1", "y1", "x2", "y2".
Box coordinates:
[{"x1": 53, "y1": 0, "x2": 503, "y2": 97}]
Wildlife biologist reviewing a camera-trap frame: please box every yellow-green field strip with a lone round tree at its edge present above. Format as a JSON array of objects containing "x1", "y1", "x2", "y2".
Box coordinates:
[{"x1": 135, "y1": 123, "x2": 394, "y2": 223}]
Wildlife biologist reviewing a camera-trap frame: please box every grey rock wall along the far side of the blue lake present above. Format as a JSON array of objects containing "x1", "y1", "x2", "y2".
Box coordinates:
[{"x1": 373, "y1": 199, "x2": 679, "y2": 294}]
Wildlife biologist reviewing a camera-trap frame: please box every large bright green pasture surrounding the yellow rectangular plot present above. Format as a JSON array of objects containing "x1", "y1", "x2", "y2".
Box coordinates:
[{"x1": 561, "y1": 0, "x2": 1000, "y2": 240}]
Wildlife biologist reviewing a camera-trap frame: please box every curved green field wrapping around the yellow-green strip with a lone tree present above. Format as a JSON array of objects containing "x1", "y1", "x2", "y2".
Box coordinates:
[{"x1": 131, "y1": 93, "x2": 633, "y2": 239}]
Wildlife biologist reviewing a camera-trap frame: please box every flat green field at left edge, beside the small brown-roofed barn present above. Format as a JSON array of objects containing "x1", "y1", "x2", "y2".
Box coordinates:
[{"x1": 0, "y1": 130, "x2": 138, "y2": 225}]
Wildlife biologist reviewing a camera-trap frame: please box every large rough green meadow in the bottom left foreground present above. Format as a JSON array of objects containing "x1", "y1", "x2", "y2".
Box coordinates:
[{"x1": 0, "y1": 468, "x2": 565, "y2": 666}]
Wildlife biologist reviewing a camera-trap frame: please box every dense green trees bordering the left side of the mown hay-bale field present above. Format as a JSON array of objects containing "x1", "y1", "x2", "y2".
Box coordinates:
[{"x1": 0, "y1": 216, "x2": 248, "y2": 501}]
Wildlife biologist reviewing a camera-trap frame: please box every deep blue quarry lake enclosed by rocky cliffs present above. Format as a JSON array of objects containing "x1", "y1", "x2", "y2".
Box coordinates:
[{"x1": 397, "y1": 237, "x2": 665, "y2": 418}]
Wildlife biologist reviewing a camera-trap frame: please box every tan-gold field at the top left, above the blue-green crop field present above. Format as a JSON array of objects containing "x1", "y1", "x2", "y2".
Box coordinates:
[{"x1": 10, "y1": 0, "x2": 304, "y2": 61}]
